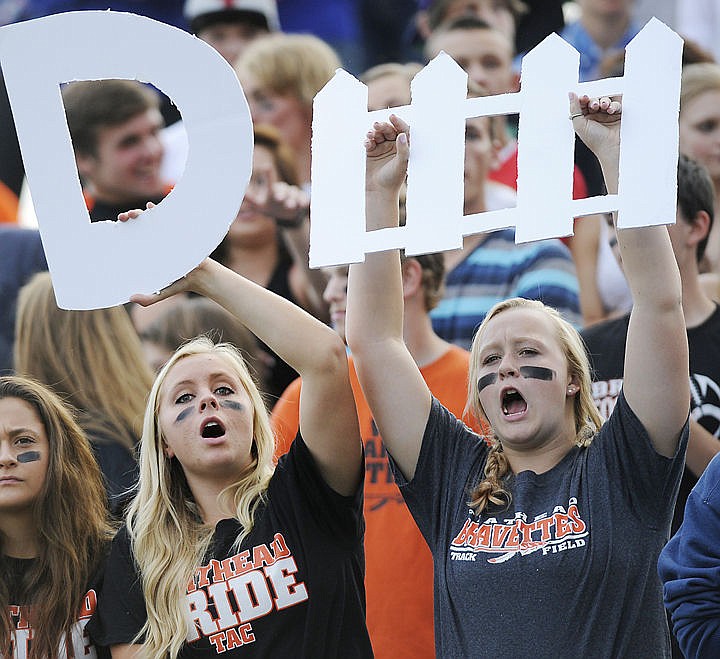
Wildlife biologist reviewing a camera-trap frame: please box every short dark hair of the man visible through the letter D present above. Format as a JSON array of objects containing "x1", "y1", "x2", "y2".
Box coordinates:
[{"x1": 62, "y1": 80, "x2": 160, "y2": 156}]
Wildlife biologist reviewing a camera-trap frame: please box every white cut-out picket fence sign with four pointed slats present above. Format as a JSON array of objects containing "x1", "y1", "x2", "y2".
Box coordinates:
[{"x1": 310, "y1": 19, "x2": 682, "y2": 267}]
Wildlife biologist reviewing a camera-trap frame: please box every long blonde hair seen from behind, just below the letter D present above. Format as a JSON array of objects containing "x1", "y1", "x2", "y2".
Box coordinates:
[{"x1": 14, "y1": 272, "x2": 152, "y2": 451}]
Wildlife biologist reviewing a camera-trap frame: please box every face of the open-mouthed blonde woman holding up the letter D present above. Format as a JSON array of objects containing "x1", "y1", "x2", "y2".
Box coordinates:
[{"x1": 158, "y1": 353, "x2": 254, "y2": 487}]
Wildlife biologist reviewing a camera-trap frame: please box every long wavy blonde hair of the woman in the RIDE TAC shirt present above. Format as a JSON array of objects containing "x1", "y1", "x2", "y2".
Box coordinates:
[{"x1": 125, "y1": 337, "x2": 275, "y2": 659}]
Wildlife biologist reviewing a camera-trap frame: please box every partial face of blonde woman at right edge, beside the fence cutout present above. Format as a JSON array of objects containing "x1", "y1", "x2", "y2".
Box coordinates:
[{"x1": 680, "y1": 90, "x2": 720, "y2": 185}]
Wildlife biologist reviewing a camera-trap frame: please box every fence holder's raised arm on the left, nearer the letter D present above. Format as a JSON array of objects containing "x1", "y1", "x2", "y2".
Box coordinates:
[{"x1": 344, "y1": 117, "x2": 431, "y2": 480}]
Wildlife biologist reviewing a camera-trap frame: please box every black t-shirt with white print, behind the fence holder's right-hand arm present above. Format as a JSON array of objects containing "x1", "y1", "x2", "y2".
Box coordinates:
[{"x1": 582, "y1": 306, "x2": 720, "y2": 534}]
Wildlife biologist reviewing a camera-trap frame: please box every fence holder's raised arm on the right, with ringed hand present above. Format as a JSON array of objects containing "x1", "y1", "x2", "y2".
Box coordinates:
[{"x1": 570, "y1": 94, "x2": 690, "y2": 457}]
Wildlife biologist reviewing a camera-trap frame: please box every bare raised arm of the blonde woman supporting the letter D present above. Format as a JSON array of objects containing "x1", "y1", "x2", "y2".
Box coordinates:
[{"x1": 133, "y1": 259, "x2": 362, "y2": 495}]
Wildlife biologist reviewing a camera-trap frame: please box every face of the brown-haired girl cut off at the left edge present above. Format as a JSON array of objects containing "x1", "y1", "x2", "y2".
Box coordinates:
[{"x1": 0, "y1": 398, "x2": 50, "y2": 517}]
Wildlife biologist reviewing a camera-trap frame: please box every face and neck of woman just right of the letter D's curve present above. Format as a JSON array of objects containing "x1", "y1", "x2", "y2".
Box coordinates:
[{"x1": 228, "y1": 144, "x2": 278, "y2": 247}]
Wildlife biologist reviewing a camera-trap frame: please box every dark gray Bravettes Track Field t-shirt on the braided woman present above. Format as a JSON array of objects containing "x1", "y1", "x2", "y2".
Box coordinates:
[{"x1": 393, "y1": 395, "x2": 687, "y2": 659}]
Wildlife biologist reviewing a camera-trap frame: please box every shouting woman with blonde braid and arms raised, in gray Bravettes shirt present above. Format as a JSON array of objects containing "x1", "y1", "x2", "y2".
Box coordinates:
[{"x1": 346, "y1": 94, "x2": 689, "y2": 658}]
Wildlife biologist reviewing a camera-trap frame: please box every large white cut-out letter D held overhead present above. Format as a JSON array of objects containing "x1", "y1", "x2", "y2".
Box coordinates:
[{"x1": 0, "y1": 11, "x2": 253, "y2": 309}]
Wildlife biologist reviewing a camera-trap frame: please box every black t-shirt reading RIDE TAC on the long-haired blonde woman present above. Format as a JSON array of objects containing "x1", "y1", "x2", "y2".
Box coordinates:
[{"x1": 88, "y1": 435, "x2": 372, "y2": 659}]
